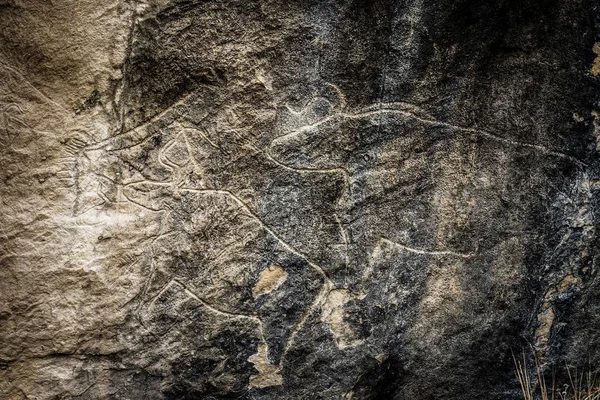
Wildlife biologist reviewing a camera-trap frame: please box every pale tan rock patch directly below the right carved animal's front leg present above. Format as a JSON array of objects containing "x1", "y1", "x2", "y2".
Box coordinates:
[{"x1": 321, "y1": 289, "x2": 362, "y2": 349}]
